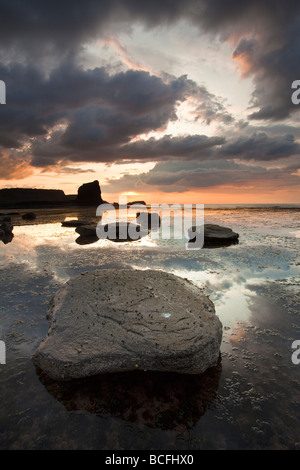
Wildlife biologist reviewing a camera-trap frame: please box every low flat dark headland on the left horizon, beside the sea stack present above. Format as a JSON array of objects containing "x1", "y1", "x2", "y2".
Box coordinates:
[{"x1": 0, "y1": 188, "x2": 68, "y2": 207}]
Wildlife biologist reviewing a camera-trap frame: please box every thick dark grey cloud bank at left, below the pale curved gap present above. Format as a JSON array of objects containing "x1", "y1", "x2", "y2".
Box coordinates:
[{"x1": 0, "y1": 62, "x2": 232, "y2": 166}]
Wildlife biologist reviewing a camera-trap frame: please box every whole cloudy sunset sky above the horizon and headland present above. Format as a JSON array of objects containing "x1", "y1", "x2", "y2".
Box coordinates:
[{"x1": 0, "y1": 0, "x2": 300, "y2": 204}]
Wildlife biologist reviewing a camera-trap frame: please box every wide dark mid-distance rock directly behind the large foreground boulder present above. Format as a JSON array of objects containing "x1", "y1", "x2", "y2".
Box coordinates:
[{"x1": 97, "y1": 222, "x2": 149, "y2": 242}]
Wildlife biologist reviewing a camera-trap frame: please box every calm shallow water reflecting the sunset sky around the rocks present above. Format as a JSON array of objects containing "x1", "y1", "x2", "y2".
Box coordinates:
[{"x1": 0, "y1": 207, "x2": 300, "y2": 450}]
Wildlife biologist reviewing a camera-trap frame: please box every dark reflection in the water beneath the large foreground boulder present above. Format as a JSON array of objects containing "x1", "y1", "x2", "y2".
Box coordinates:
[{"x1": 38, "y1": 358, "x2": 222, "y2": 432}]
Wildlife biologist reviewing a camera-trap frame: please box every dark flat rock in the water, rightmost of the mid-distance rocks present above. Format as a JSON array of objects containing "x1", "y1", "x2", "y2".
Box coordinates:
[{"x1": 188, "y1": 224, "x2": 239, "y2": 248}]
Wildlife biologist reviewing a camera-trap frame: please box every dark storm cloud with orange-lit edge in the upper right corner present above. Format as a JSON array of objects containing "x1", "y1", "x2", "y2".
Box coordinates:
[{"x1": 198, "y1": 0, "x2": 300, "y2": 121}]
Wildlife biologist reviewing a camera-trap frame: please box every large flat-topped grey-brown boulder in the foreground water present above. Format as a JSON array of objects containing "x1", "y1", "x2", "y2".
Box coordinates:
[{"x1": 33, "y1": 269, "x2": 222, "y2": 380}]
